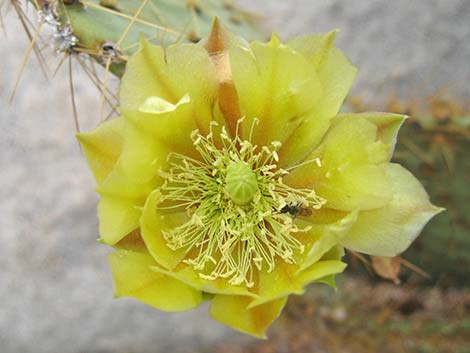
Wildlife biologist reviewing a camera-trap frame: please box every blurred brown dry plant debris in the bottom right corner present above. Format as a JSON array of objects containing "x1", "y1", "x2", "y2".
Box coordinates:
[{"x1": 213, "y1": 278, "x2": 470, "y2": 353}]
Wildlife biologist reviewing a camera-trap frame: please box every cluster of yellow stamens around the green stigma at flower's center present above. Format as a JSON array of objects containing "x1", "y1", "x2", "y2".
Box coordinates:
[{"x1": 157, "y1": 120, "x2": 326, "y2": 287}]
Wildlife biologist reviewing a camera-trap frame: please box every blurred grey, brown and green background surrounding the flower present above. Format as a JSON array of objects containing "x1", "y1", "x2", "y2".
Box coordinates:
[{"x1": 0, "y1": 0, "x2": 470, "y2": 353}]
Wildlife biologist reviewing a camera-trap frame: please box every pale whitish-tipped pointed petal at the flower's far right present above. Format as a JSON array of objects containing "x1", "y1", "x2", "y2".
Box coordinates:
[{"x1": 342, "y1": 164, "x2": 443, "y2": 257}]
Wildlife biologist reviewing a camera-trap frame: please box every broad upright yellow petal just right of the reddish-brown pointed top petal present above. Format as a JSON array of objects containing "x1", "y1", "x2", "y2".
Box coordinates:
[{"x1": 230, "y1": 36, "x2": 322, "y2": 145}]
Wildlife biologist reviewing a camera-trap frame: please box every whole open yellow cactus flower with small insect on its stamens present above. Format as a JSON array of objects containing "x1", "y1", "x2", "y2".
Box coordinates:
[{"x1": 78, "y1": 21, "x2": 440, "y2": 337}]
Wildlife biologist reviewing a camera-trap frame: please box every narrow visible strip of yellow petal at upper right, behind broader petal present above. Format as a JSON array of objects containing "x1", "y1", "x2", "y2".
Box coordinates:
[{"x1": 280, "y1": 43, "x2": 357, "y2": 166}]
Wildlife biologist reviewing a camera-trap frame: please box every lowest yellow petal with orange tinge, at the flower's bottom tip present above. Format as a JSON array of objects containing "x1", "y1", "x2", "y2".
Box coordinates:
[{"x1": 210, "y1": 294, "x2": 287, "y2": 338}]
